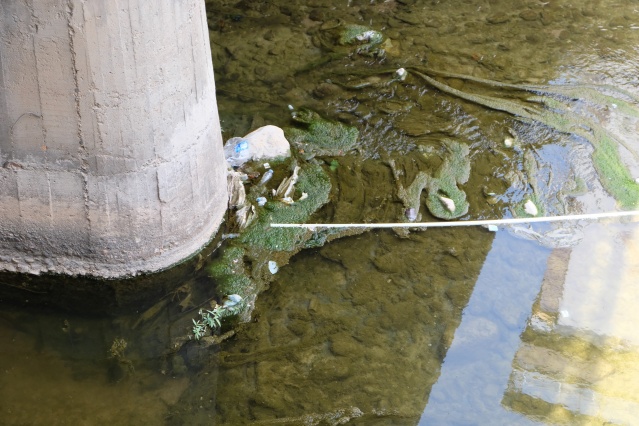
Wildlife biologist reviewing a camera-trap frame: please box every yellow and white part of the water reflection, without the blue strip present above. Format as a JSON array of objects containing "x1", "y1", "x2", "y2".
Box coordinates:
[{"x1": 503, "y1": 225, "x2": 639, "y2": 424}]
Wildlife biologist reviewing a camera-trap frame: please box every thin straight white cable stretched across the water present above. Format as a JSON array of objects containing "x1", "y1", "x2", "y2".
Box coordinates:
[{"x1": 271, "y1": 210, "x2": 639, "y2": 231}]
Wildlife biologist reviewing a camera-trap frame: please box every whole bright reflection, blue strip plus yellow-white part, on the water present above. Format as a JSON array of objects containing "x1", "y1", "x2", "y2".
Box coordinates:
[{"x1": 422, "y1": 224, "x2": 639, "y2": 424}]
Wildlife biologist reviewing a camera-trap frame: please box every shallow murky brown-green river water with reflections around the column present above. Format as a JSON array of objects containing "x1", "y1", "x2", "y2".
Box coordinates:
[{"x1": 0, "y1": 0, "x2": 639, "y2": 425}]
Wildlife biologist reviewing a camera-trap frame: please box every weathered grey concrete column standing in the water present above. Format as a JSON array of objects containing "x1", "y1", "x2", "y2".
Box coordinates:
[{"x1": 0, "y1": 0, "x2": 226, "y2": 277}]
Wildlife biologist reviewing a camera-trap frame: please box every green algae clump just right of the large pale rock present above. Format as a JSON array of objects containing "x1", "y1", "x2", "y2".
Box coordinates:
[{"x1": 284, "y1": 108, "x2": 359, "y2": 159}]
